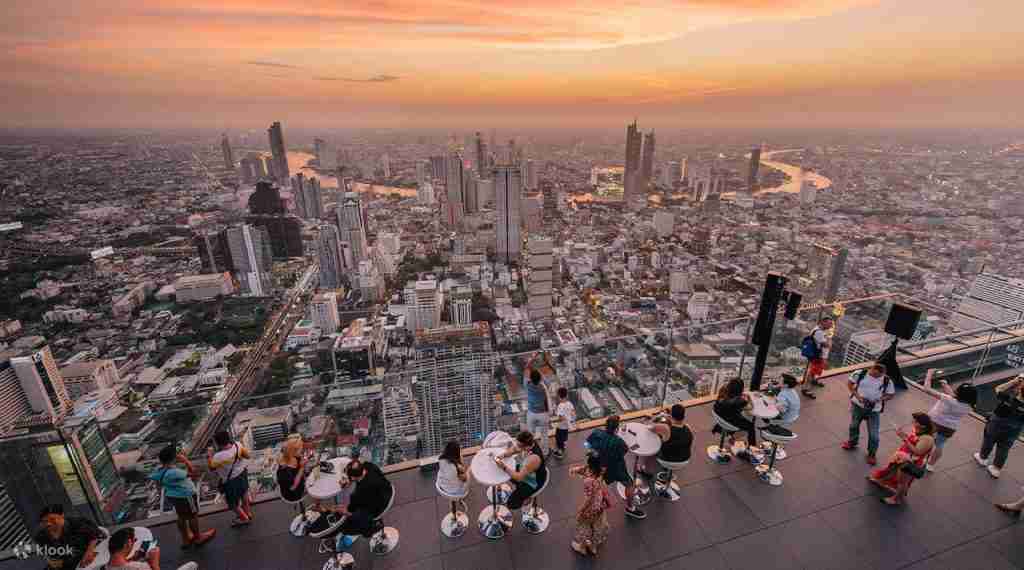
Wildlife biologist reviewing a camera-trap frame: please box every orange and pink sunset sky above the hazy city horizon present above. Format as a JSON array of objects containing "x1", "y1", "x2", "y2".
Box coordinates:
[{"x1": 0, "y1": 0, "x2": 1024, "y2": 128}]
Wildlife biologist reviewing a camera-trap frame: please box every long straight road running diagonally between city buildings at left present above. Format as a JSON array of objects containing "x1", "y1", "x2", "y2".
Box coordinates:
[{"x1": 188, "y1": 263, "x2": 319, "y2": 454}]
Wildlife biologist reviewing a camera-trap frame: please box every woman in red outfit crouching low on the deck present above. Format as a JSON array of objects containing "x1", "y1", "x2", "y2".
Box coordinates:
[{"x1": 867, "y1": 411, "x2": 935, "y2": 505}]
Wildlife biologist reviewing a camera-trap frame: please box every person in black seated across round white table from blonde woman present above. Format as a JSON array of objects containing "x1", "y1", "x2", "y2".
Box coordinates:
[{"x1": 325, "y1": 459, "x2": 394, "y2": 552}]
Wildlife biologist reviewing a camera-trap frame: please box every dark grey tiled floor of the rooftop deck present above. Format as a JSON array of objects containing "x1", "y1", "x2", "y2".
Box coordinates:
[{"x1": 0, "y1": 370, "x2": 1024, "y2": 570}]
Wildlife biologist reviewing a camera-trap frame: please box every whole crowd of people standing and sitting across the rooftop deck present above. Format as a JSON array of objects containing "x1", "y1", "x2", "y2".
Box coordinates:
[{"x1": 29, "y1": 339, "x2": 1024, "y2": 570}]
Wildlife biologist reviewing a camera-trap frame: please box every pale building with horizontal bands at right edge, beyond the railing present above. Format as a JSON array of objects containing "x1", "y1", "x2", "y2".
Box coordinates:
[{"x1": 950, "y1": 273, "x2": 1024, "y2": 331}]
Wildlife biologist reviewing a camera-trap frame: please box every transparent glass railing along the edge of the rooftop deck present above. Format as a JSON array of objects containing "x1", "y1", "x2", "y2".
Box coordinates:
[{"x1": 0, "y1": 295, "x2": 1024, "y2": 549}]
